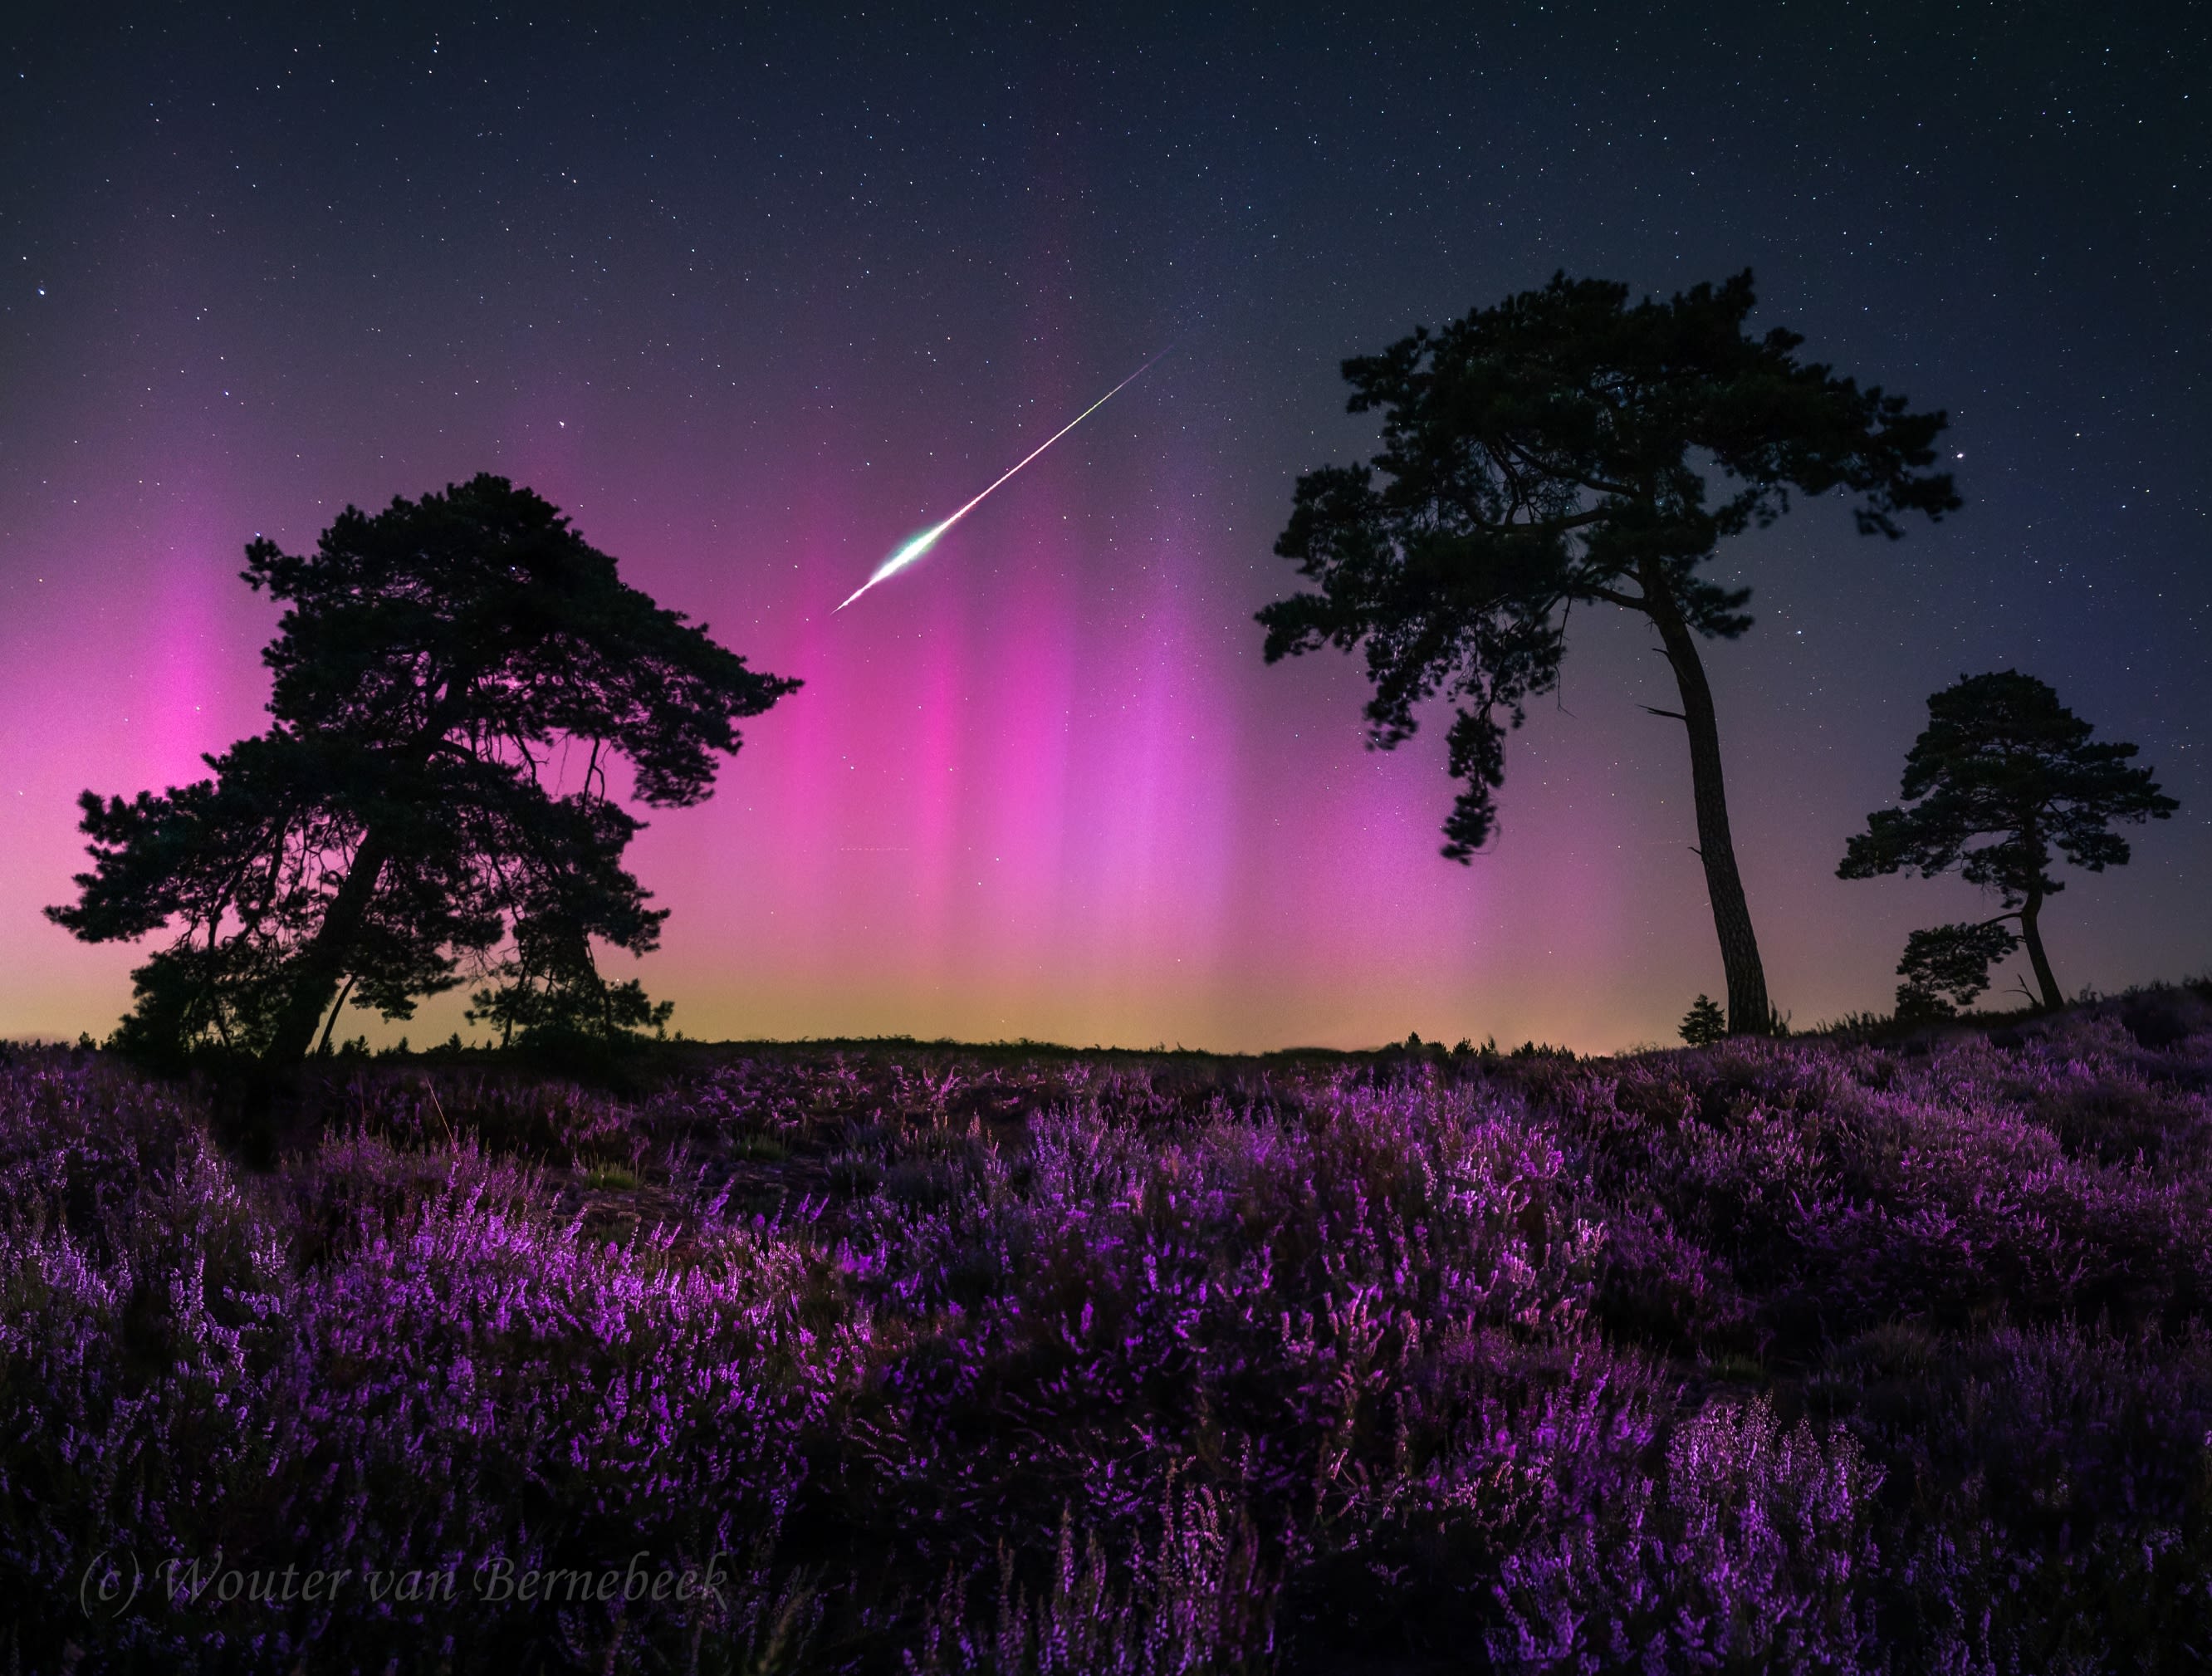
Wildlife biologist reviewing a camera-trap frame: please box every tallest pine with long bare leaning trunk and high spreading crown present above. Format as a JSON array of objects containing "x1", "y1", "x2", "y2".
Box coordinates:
[{"x1": 1259, "y1": 272, "x2": 1960, "y2": 1035}]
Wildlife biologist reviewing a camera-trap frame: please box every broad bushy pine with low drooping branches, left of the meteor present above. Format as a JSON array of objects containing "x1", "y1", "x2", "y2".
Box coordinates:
[{"x1": 49, "y1": 475, "x2": 799, "y2": 1066}]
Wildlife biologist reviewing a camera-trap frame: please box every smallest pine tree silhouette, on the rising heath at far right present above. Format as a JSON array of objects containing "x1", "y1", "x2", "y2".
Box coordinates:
[{"x1": 1836, "y1": 670, "x2": 2181, "y2": 1012}]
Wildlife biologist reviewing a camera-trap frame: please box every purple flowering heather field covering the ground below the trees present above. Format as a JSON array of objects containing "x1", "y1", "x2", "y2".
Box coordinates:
[{"x1": 0, "y1": 988, "x2": 2212, "y2": 1676}]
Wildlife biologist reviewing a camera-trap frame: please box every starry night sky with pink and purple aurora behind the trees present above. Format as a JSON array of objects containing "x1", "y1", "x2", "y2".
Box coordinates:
[{"x1": 0, "y1": 0, "x2": 2212, "y2": 1051}]
